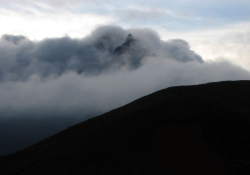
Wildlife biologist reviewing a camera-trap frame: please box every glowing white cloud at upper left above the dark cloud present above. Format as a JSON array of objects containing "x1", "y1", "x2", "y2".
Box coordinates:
[{"x1": 0, "y1": 5, "x2": 114, "y2": 40}]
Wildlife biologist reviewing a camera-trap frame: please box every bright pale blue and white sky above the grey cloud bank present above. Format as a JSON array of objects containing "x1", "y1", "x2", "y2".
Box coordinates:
[{"x1": 0, "y1": 0, "x2": 250, "y2": 70}]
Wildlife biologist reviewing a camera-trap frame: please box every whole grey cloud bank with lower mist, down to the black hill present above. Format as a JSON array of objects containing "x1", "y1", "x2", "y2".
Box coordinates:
[{"x1": 0, "y1": 26, "x2": 250, "y2": 155}]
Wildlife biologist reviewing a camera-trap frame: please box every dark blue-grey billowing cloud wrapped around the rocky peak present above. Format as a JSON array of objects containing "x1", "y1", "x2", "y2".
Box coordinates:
[{"x1": 0, "y1": 26, "x2": 203, "y2": 81}]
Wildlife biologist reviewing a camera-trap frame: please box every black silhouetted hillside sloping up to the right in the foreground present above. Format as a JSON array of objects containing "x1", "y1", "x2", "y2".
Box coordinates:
[{"x1": 0, "y1": 81, "x2": 250, "y2": 175}]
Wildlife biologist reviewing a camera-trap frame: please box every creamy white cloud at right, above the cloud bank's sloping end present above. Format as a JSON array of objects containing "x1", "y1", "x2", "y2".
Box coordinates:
[{"x1": 156, "y1": 22, "x2": 250, "y2": 70}]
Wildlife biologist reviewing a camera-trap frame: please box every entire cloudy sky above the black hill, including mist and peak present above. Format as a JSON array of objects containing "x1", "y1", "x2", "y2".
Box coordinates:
[{"x1": 0, "y1": 0, "x2": 250, "y2": 155}]
